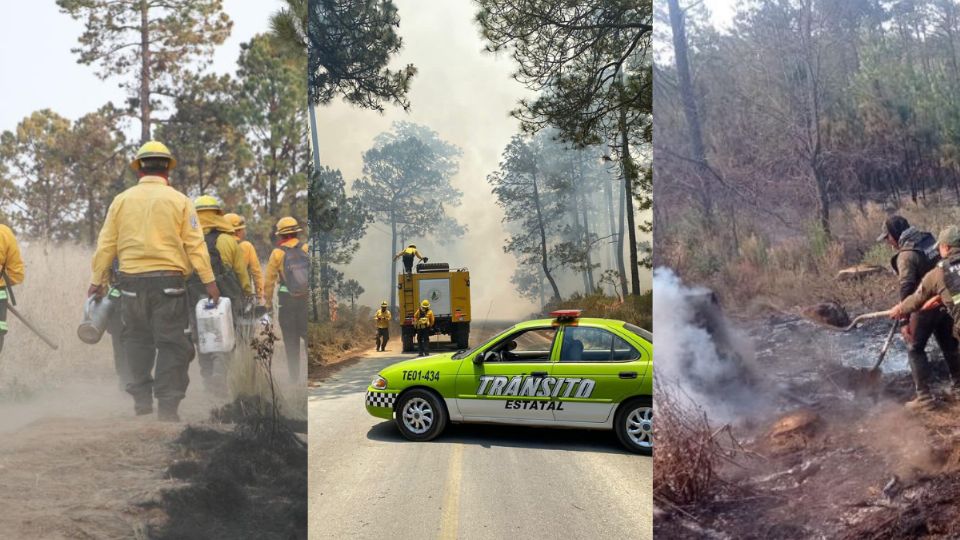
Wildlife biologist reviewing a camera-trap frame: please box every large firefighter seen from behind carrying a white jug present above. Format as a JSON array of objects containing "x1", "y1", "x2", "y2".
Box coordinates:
[{"x1": 88, "y1": 141, "x2": 220, "y2": 421}]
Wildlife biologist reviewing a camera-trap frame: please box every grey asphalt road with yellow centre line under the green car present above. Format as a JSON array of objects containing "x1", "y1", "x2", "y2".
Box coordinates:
[{"x1": 309, "y1": 341, "x2": 653, "y2": 540}]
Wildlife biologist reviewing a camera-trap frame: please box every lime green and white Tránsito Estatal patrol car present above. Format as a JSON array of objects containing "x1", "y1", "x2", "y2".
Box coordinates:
[{"x1": 366, "y1": 310, "x2": 653, "y2": 454}]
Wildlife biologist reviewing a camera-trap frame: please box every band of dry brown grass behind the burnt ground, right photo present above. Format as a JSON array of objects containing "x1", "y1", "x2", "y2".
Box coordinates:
[{"x1": 658, "y1": 203, "x2": 960, "y2": 311}]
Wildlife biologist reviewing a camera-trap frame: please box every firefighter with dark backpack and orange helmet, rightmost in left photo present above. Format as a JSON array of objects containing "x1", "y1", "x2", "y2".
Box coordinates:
[{"x1": 263, "y1": 217, "x2": 310, "y2": 381}]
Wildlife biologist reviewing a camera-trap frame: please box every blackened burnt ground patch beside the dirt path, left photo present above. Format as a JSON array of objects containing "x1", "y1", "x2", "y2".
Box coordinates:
[{"x1": 149, "y1": 402, "x2": 307, "y2": 540}]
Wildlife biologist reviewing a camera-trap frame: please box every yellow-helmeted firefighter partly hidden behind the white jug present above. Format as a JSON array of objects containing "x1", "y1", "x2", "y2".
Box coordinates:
[{"x1": 191, "y1": 195, "x2": 253, "y2": 392}]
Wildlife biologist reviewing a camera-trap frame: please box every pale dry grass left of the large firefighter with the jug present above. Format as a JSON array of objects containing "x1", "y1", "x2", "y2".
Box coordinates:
[{"x1": 0, "y1": 243, "x2": 113, "y2": 400}]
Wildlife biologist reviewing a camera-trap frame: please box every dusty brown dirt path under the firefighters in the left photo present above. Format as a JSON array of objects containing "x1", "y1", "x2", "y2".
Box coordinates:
[{"x1": 0, "y1": 358, "x2": 306, "y2": 539}]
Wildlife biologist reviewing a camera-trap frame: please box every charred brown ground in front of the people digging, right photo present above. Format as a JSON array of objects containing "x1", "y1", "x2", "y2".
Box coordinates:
[{"x1": 655, "y1": 316, "x2": 960, "y2": 539}]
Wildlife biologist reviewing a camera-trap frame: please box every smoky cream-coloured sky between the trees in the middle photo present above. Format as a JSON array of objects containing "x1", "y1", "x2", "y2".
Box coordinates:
[{"x1": 317, "y1": 0, "x2": 650, "y2": 321}]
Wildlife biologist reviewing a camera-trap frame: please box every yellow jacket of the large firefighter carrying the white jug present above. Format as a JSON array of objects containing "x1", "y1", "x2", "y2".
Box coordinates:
[{"x1": 92, "y1": 176, "x2": 214, "y2": 285}]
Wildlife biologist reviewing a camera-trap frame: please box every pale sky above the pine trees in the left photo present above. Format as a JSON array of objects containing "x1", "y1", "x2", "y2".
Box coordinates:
[{"x1": 0, "y1": 0, "x2": 282, "y2": 133}]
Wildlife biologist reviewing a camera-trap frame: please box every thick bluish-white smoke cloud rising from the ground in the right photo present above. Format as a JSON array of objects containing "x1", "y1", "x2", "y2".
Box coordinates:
[{"x1": 653, "y1": 267, "x2": 763, "y2": 421}]
